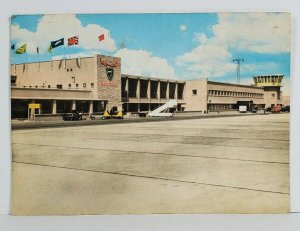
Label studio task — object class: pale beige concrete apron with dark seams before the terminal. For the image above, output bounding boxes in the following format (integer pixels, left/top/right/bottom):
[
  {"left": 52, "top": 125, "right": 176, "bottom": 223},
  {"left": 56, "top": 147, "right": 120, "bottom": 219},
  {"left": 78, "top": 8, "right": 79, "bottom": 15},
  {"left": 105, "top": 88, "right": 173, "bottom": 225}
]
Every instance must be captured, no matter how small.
[{"left": 12, "top": 114, "right": 289, "bottom": 215}]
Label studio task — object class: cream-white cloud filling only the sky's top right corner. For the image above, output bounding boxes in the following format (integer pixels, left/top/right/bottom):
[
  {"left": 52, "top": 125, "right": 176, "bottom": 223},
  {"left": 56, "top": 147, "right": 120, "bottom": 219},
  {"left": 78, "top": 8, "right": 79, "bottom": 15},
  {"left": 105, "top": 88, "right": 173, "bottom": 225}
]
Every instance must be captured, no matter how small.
[{"left": 212, "top": 13, "right": 290, "bottom": 54}]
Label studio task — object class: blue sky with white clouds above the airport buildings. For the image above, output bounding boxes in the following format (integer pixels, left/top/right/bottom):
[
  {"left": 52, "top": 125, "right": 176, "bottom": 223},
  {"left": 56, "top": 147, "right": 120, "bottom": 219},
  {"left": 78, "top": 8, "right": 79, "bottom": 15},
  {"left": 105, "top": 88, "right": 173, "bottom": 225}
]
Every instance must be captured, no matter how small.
[{"left": 10, "top": 13, "right": 290, "bottom": 95}]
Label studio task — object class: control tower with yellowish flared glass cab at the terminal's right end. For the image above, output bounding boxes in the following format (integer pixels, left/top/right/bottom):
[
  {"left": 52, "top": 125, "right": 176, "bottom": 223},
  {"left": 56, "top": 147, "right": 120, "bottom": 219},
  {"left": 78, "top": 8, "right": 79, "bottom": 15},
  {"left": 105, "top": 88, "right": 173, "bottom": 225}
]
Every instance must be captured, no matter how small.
[{"left": 253, "top": 74, "right": 284, "bottom": 107}]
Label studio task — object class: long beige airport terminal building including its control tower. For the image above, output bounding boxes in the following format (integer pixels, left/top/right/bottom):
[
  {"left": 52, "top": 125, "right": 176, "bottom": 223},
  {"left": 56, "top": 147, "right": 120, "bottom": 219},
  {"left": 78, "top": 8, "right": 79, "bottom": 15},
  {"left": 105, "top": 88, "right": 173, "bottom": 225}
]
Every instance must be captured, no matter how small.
[{"left": 11, "top": 55, "right": 283, "bottom": 118}]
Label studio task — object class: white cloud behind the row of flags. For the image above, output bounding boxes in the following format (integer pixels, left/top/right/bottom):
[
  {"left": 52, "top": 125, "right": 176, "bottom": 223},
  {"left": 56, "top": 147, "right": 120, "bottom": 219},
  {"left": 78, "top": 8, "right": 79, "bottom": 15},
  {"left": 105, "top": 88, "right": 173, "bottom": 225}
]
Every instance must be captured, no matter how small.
[{"left": 11, "top": 14, "right": 116, "bottom": 53}]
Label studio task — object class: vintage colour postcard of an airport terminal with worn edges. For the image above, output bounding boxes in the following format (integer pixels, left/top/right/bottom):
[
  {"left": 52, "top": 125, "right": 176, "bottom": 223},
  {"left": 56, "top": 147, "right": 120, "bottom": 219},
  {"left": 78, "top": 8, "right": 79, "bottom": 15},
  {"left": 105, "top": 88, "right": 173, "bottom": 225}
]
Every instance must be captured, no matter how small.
[{"left": 10, "top": 12, "right": 291, "bottom": 215}]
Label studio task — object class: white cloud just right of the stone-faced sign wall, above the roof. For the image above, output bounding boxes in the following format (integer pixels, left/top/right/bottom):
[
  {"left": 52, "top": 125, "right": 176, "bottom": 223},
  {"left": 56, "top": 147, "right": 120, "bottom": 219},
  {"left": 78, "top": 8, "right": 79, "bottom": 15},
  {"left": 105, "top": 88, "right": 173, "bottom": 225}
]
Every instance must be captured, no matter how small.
[{"left": 114, "top": 48, "right": 176, "bottom": 78}]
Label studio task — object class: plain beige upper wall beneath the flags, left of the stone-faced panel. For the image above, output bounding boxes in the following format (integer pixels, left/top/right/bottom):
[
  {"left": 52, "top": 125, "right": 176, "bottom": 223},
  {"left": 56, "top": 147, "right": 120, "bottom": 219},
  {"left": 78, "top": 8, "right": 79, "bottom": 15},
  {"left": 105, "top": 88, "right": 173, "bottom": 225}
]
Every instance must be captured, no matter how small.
[{"left": 11, "top": 57, "right": 98, "bottom": 99}]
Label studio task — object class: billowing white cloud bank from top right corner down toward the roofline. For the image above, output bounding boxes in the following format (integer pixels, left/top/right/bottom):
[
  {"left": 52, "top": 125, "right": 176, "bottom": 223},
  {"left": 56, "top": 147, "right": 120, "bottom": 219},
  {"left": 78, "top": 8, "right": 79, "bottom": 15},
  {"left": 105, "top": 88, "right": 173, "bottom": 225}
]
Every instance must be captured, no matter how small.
[{"left": 176, "top": 13, "right": 290, "bottom": 78}]
